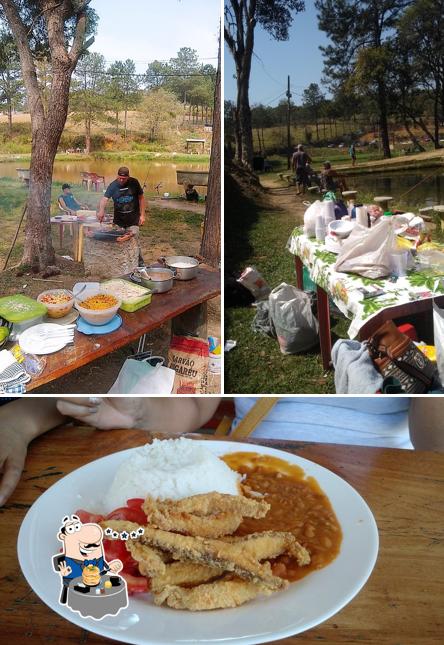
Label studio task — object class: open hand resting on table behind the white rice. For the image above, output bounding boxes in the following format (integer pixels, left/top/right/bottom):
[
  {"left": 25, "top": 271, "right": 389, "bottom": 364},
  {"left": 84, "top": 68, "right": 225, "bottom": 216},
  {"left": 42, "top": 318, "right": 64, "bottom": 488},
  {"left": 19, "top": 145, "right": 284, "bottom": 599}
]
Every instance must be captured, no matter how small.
[{"left": 57, "top": 397, "right": 143, "bottom": 430}]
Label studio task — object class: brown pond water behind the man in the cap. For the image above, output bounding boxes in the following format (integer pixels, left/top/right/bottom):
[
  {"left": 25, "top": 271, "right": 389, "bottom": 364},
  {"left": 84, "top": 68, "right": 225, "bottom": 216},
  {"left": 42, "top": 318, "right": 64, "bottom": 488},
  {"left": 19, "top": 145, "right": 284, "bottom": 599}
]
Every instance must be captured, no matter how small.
[{"left": 0, "top": 159, "right": 208, "bottom": 195}]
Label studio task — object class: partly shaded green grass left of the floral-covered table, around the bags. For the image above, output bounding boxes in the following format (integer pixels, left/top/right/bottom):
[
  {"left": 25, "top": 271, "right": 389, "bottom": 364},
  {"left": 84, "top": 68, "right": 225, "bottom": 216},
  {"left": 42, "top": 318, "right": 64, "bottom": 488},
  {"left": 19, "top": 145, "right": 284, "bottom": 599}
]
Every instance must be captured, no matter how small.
[{"left": 225, "top": 174, "right": 335, "bottom": 394}]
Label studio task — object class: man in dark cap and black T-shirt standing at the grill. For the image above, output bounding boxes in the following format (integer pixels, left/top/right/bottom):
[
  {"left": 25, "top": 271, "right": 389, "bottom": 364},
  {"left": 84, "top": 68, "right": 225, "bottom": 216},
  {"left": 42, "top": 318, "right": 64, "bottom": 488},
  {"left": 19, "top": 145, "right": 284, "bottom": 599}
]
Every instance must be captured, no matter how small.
[{"left": 97, "top": 166, "right": 145, "bottom": 264}]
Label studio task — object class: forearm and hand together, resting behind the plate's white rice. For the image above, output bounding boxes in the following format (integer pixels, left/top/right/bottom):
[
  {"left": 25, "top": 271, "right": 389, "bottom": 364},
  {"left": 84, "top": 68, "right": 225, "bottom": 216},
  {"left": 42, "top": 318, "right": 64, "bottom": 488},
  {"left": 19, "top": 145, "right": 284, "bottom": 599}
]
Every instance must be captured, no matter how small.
[{"left": 57, "top": 397, "right": 220, "bottom": 435}]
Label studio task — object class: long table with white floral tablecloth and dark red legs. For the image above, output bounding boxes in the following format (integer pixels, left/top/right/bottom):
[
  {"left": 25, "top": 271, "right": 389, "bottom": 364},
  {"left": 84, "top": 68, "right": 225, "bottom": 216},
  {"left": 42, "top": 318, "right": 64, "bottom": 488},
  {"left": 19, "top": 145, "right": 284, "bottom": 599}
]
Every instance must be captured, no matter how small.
[{"left": 287, "top": 226, "right": 444, "bottom": 369}]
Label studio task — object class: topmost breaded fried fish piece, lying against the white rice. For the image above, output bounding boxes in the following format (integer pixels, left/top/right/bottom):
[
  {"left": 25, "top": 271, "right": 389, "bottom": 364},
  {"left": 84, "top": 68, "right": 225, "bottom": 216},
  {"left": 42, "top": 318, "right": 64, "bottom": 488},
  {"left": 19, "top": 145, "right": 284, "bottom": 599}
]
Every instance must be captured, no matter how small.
[{"left": 143, "top": 493, "right": 270, "bottom": 538}]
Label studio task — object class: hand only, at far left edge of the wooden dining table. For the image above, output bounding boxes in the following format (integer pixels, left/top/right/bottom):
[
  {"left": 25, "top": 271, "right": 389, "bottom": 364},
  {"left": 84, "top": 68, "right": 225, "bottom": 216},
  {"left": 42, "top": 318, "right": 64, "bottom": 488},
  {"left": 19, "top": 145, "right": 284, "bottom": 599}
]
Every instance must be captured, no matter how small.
[{"left": 0, "top": 428, "right": 28, "bottom": 506}]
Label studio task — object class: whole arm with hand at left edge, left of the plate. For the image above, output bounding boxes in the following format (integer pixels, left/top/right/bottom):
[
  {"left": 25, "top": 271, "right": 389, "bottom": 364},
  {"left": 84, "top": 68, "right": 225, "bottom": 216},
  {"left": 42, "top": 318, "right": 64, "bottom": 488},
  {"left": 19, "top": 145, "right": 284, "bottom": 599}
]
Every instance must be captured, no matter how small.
[{"left": 0, "top": 398, "right": 66, "bottom": 506}]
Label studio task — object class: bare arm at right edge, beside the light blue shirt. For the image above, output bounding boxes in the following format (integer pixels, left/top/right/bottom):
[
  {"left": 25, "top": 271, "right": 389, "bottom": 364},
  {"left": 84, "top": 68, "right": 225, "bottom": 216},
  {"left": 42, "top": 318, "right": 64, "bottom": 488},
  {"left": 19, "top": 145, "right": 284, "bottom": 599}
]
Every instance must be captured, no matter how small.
[{"left": 409, "top": 396, "right": 444, "bottom": 452}]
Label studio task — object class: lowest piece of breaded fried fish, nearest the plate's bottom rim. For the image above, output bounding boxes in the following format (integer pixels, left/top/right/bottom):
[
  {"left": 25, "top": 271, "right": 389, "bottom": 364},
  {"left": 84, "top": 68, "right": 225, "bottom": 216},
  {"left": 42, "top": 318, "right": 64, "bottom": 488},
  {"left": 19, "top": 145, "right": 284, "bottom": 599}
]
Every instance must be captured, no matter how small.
[{"left": 154, "top": 580, "right": 272, "bottom": 611}]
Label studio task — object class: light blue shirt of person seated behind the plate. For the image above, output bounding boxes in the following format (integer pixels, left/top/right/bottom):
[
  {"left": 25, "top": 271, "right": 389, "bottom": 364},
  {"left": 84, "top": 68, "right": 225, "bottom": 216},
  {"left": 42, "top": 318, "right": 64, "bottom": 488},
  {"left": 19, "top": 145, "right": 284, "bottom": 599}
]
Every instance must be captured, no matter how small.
[{"left": 233, "top": 395, "right": 413, "bottom": 449}]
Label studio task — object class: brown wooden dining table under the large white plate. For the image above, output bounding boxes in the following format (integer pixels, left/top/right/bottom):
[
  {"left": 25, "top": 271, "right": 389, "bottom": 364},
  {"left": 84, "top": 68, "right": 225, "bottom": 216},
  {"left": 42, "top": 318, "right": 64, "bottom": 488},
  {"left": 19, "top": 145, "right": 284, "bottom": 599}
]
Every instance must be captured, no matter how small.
[{"left": 0, "top": 426, "right": 444, "bottom": 645}]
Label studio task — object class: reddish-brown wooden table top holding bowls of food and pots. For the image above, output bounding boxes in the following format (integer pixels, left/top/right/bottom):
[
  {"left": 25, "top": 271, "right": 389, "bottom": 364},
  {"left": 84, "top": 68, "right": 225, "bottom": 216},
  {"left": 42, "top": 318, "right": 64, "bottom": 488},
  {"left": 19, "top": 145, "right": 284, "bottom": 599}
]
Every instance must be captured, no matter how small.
[{"left": 27, "top": 264, "right": 220, "bottom": 391}]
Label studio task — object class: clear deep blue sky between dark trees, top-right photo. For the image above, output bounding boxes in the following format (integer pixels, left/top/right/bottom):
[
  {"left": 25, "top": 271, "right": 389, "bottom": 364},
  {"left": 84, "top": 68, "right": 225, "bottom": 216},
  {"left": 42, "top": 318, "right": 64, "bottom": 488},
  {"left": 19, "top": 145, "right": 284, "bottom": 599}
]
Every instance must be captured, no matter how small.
[{"left": 224, "top": 0, "right": 327, "bottom": 106}]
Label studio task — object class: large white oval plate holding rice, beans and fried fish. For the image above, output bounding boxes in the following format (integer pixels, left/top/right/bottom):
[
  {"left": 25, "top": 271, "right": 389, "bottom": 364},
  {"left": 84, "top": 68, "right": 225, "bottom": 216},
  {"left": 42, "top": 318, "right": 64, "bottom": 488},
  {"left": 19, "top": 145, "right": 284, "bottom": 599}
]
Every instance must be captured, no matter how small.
[{"left": 17, "top": 441, "right": 378, "bottom": 645}]
